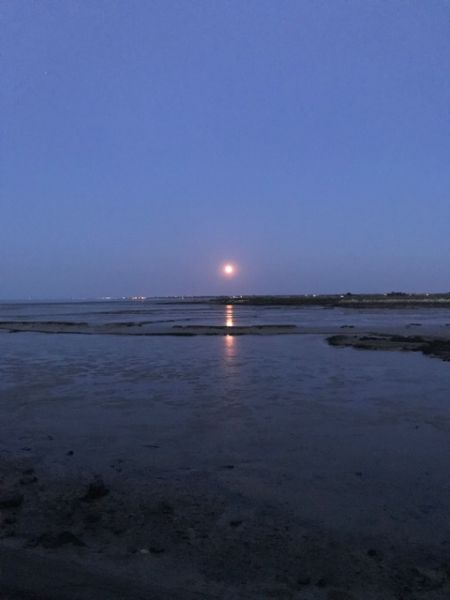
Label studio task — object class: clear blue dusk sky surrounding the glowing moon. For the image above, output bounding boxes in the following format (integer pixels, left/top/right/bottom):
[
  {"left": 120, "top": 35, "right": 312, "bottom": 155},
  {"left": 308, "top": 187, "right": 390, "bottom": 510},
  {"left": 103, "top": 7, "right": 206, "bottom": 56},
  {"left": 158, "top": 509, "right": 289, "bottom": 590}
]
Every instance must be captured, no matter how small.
[{"left": 0, "top": 0, "right": 450, "bottom": 299}]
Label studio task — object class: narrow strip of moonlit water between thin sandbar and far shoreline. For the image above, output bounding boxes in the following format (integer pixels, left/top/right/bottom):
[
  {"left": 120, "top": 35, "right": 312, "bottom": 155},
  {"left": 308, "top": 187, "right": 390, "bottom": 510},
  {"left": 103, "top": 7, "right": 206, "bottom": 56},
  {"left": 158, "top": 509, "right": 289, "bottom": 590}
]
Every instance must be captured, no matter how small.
[{"left": 0, "top": 300, "right": 450, "bottom": 327}]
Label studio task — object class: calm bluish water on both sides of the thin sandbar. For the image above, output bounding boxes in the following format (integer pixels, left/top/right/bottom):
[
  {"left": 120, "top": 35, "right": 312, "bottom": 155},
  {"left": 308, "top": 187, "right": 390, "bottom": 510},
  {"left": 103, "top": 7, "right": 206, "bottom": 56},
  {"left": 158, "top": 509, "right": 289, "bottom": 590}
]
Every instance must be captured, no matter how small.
[{"left": 0, "top": 302, "right": 450, "bottom": 540}]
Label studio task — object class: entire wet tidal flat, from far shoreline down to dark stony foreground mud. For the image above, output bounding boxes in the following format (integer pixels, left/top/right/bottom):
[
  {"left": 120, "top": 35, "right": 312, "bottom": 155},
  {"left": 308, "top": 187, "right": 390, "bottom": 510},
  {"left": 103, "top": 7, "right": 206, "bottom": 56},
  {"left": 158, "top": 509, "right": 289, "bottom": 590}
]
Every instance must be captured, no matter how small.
[{"left": 0, "top": 303, "right": 450, "bottom": 600}]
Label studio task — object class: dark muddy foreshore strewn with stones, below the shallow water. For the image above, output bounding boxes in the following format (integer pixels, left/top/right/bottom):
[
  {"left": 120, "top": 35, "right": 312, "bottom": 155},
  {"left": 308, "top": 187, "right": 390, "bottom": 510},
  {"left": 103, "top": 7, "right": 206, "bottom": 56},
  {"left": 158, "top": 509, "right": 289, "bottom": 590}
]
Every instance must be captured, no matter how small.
[{"left": 0, "top": 436, "right": 450, "bottom": 600}]
